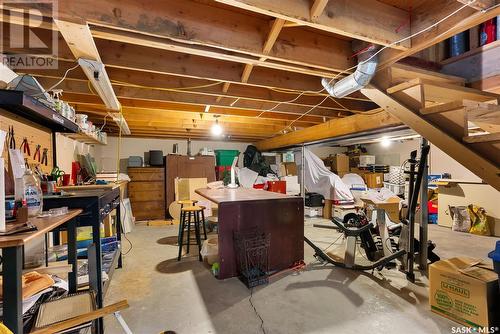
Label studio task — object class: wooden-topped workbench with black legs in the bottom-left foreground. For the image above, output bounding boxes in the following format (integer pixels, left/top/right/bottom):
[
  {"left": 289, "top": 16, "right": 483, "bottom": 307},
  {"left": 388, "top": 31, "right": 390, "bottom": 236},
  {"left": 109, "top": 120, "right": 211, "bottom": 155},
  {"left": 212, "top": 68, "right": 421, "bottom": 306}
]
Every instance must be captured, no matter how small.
[{"left": 0, "top": 209, "right": 82, "bottom": 333}]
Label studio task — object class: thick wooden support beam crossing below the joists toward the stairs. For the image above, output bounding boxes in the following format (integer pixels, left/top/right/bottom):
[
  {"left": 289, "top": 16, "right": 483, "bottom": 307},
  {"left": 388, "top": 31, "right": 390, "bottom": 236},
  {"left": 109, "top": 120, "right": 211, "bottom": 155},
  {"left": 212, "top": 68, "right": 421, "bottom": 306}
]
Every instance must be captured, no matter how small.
[{"left": 256, "top": 110, "right": 401, "bottom": 151}]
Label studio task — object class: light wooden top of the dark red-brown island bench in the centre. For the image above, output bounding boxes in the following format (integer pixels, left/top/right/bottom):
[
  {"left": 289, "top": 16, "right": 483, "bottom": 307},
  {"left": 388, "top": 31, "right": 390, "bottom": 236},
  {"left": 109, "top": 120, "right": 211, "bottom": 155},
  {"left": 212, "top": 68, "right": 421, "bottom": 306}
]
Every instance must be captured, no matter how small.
[{"left": 195, "top": 187, "right": 298, "bottom": 204}]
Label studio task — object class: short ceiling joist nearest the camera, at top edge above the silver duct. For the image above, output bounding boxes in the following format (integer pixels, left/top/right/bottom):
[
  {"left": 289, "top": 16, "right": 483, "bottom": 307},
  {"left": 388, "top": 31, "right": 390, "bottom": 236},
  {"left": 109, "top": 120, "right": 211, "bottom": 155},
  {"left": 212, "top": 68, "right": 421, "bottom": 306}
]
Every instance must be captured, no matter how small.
[{"left": 216, "top": 0, "right": 410, "bottom": 50}]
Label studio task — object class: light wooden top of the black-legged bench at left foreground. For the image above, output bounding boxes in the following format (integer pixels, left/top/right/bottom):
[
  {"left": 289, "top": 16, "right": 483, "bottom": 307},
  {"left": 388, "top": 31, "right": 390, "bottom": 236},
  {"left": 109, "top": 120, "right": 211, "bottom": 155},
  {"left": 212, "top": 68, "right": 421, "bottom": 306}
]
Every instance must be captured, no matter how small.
[{"left": 0, "top": 209, "right": 82, "bottom": 248}]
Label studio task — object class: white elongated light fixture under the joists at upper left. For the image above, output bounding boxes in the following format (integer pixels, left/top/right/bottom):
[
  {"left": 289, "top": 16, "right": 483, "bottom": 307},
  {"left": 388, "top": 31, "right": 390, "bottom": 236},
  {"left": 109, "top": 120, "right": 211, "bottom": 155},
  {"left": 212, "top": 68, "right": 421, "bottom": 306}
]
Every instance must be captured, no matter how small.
[{"left": 78, "top": 58, "right": 120, "bottom": 111}]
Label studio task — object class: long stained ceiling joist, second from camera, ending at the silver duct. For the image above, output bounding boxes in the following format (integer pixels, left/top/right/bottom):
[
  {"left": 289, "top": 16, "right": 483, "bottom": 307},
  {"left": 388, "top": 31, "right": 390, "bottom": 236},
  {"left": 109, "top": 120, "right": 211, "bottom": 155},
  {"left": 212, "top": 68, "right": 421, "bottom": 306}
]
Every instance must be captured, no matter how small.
[{"left": 34, "top": 0, "right": 352, "bottom": 74}]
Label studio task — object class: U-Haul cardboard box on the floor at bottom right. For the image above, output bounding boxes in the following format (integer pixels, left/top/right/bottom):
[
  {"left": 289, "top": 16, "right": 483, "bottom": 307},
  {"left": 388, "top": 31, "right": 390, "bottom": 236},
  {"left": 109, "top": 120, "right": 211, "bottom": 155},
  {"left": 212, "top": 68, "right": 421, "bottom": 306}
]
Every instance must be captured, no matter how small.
[{"left": 429, "top": 257, "right": 500, "bottom": 333}]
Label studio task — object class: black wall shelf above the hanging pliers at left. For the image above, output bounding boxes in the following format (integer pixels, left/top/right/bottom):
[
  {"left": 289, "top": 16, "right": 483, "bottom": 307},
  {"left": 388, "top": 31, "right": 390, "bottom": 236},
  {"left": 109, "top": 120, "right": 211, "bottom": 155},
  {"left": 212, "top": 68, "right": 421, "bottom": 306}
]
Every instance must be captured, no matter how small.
[{"left": 0, "top": 89, "right": 78, "bottom": 133}]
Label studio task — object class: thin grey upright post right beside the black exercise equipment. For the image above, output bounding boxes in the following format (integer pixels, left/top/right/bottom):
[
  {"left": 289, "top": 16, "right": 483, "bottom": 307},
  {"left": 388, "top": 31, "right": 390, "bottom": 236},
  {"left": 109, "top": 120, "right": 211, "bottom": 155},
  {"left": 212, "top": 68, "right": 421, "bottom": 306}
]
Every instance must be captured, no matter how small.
[{"left": 419, "top": 137, "right": 430, "bottom": 271}]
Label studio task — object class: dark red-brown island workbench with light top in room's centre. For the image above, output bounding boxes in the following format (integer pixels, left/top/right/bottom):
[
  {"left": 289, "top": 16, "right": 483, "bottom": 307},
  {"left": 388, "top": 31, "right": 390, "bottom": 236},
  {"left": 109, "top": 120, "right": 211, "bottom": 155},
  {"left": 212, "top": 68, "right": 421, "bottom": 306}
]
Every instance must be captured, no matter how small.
[{"left": 196, "top": 188, "right": 304, "bottom": 279}]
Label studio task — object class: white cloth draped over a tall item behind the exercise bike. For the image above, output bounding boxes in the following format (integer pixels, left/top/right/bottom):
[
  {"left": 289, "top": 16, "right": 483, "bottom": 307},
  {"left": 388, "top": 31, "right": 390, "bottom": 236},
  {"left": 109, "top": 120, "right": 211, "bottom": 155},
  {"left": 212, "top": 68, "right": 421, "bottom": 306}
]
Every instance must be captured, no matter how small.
[{"left": 304, "top": 148, "right": 354, "bottom": 201}]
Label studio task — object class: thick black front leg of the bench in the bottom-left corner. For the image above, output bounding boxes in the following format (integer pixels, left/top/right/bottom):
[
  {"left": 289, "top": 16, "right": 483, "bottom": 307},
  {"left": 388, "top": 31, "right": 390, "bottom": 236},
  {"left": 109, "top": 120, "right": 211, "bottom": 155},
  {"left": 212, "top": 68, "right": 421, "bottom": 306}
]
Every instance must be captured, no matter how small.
[{"left": 2, "top": 246, "right": 23, "bottom": 334}]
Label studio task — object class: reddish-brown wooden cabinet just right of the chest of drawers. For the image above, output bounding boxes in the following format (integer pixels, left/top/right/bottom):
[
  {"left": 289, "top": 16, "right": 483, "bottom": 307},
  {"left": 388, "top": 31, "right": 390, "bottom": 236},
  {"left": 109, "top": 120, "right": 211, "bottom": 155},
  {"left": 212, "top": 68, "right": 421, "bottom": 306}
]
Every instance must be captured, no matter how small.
[{"left": 165, "top": 155, "right": 215, "bottom": 208}]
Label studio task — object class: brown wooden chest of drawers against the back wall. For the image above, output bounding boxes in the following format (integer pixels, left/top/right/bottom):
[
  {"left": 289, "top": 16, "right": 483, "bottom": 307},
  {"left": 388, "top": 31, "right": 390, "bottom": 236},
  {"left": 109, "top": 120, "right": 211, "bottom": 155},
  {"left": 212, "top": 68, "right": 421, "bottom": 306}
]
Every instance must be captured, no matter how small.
[{"left": 128, "top": 167, "right": 166, "bottom": 220}]
